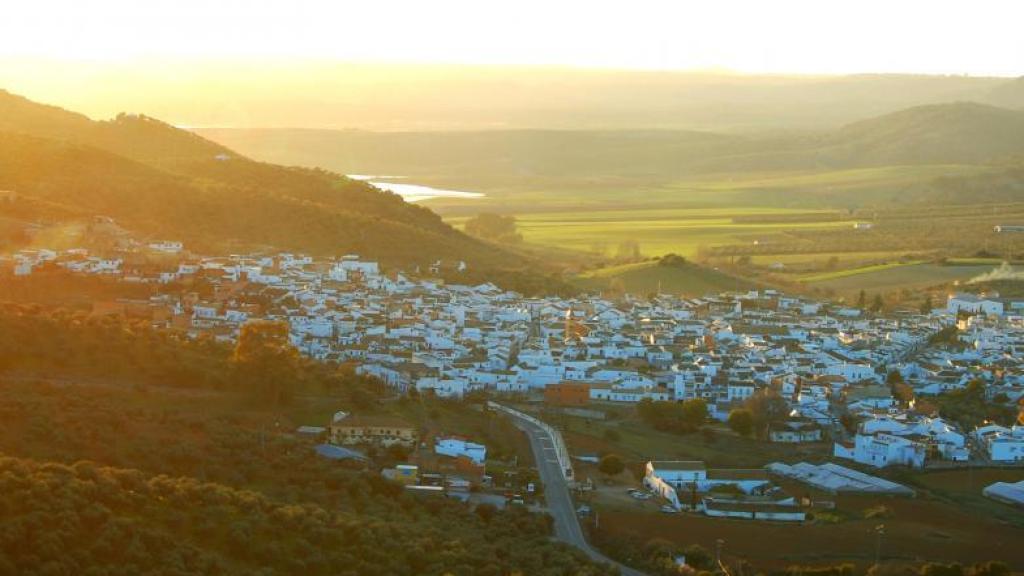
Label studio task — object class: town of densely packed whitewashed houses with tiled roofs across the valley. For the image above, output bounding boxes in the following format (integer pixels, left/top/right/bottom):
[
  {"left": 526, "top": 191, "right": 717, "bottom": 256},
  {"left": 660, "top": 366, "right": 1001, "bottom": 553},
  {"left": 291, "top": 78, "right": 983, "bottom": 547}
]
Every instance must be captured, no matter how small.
[{"left": 4, "top": 241, "right": 1024, "bottom": 466}]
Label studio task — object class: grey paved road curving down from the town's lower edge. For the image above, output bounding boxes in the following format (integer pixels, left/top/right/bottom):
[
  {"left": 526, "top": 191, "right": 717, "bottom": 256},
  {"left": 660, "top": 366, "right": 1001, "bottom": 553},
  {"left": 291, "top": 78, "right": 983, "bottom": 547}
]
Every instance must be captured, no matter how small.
[{"left": 513, "top": 409, "right": 645, "bottom": 576}]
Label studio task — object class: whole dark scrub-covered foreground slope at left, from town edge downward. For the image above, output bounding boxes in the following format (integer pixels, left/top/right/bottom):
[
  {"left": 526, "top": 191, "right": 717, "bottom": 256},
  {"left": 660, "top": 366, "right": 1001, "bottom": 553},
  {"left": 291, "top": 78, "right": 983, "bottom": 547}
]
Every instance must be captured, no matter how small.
[{"left": 0, "top": 307, "right": 604, "bottom": 575}]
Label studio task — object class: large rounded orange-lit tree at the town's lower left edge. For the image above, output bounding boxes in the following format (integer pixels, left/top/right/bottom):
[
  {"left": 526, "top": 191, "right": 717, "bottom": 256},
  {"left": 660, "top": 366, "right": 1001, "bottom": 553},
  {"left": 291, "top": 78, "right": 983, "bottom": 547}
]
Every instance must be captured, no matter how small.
[{"left": 231, "top": 321, "right": 301, "bottom": 405}]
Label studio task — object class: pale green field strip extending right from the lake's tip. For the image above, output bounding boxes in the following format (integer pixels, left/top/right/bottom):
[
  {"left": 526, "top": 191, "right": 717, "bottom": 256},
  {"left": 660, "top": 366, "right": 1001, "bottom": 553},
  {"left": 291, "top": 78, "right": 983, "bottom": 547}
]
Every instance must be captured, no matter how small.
[{"left": 434, "top": 164, "right": 992, "bottom": 216}]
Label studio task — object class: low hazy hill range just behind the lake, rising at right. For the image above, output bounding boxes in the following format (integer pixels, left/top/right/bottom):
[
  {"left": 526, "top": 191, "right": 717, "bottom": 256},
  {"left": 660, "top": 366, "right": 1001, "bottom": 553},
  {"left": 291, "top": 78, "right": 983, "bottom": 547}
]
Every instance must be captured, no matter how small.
[{"left": 198, "top": 101, "right": 1024, "bottom": 180}]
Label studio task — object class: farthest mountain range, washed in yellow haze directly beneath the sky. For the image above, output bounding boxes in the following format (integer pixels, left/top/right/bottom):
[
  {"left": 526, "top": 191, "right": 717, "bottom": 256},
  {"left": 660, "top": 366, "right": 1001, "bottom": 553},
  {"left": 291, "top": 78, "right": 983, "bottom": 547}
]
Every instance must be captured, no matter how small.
[{"left": 6, "top": 63, "right": 1024, "bottom": 133}]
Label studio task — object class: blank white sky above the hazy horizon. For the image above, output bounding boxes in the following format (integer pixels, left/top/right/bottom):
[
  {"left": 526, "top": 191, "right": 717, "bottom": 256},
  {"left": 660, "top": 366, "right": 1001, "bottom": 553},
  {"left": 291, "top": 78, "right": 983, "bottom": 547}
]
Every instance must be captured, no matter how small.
[{"left": 0, "top": 0, "right": 1024, "bottom": 76}]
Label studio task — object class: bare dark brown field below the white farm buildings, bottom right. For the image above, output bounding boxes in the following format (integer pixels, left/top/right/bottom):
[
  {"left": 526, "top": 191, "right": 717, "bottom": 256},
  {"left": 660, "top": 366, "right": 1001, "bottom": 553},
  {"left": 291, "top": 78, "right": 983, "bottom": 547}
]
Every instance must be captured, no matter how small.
[{"left": 594, "top": 489, "right": 1024, "bottom": 570}]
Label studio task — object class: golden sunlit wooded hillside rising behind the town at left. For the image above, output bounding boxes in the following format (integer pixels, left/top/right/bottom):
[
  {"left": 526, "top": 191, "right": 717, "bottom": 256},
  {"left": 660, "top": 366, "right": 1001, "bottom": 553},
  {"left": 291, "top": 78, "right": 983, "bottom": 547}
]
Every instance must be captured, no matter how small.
[{"left": 0, "top": 88, "right": 544, "bottom": 280}]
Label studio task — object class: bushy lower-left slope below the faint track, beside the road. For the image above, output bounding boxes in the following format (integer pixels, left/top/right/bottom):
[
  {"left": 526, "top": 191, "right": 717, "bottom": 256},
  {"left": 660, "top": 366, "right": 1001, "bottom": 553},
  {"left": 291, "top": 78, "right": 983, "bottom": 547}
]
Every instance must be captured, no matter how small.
[{"left": 0, "top": 383, "right": 600, "bottom": 575}]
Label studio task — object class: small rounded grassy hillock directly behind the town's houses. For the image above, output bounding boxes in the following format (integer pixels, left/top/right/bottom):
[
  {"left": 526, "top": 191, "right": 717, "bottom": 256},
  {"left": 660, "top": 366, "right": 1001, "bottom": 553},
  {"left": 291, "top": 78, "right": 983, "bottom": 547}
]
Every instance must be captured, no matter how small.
[{"left": 572, "top": 261, "right": 754, "bottom": 296}]
